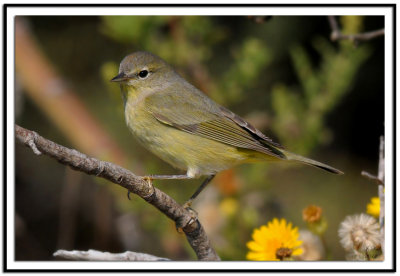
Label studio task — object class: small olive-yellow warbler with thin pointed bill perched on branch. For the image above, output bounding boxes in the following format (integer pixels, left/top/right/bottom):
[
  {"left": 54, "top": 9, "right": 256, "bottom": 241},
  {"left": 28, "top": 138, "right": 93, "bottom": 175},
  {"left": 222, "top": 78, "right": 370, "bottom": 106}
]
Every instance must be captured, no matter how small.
[{"left": 111, "top": 51, "right": 342, "bottom": 205}]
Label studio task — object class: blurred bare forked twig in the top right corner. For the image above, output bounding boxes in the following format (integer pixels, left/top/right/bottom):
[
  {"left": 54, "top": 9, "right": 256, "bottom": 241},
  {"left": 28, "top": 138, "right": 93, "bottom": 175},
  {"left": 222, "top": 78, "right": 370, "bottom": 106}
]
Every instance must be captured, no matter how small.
[{"left": 328, "top": 16, "right": 385, "bottom": 44}]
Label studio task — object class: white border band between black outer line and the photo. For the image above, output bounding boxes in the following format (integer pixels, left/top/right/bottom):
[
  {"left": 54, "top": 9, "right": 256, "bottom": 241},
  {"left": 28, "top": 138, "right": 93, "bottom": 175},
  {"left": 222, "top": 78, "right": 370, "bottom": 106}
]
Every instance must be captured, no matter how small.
[{"left": 1, "top": 6, "right": 394, "bottom": 269}]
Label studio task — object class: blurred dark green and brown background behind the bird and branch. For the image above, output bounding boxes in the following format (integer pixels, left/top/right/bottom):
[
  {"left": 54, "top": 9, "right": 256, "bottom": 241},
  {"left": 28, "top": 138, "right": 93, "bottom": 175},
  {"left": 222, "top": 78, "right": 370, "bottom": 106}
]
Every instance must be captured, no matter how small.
[{"left": 15, "top": 16, "right": 384, "bottom": 260}]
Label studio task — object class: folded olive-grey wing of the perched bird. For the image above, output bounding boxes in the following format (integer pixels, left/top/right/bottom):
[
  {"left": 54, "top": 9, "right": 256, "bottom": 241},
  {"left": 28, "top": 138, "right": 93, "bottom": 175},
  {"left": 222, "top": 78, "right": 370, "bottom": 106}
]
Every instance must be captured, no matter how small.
[{"left": 146, "top": 88, "right": 286, "bottom": 159}]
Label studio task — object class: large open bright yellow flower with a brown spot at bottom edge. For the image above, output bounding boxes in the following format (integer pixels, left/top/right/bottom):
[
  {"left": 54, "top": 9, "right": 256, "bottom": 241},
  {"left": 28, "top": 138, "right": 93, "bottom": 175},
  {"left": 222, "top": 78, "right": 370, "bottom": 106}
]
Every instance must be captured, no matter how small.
[{"left": 246, "top": 218, "right": 303, "bottom": 261}]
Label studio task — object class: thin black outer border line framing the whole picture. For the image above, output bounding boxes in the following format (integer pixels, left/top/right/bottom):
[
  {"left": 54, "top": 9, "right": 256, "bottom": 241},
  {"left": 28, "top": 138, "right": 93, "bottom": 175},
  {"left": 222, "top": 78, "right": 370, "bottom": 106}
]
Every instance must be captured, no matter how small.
[{"left": 2, "top": 3, "right": 397, "bottom": 273}]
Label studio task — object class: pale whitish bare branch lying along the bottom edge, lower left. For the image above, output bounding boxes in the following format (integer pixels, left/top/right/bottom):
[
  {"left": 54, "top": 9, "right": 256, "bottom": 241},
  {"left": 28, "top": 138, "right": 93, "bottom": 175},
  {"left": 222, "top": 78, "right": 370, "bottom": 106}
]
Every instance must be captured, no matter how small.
[{"left": 53, "top": 249, "right": 170, "bottom": 261}]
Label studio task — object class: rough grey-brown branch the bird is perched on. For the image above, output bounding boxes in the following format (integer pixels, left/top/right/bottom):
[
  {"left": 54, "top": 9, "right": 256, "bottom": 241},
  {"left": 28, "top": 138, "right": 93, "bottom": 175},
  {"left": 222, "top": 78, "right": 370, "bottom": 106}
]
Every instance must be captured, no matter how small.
[{"left": 15, "top": 125, "right": 220, "bottom": 261}]
